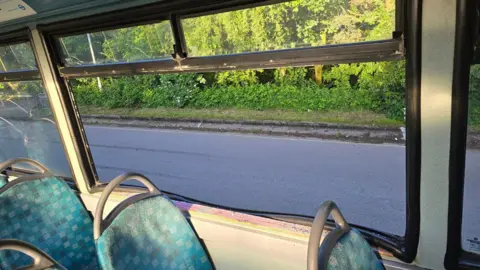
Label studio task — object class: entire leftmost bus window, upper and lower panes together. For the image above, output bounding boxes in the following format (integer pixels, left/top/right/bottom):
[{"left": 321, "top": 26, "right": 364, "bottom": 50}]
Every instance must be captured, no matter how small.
[{"left": 0, "top": 33, "right": 71, "bottom": 177}]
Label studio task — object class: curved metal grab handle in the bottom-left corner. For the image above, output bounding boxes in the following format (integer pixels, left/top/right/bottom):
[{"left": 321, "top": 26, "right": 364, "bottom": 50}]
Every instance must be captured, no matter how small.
[{"left": 0, "top": 239, "right": 63, "bottom": 270}]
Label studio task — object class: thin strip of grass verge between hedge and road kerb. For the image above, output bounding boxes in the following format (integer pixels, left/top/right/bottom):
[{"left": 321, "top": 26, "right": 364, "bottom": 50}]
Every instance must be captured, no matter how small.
[{"left": 79, "top": 106, "right": 403, "bottom": 127}]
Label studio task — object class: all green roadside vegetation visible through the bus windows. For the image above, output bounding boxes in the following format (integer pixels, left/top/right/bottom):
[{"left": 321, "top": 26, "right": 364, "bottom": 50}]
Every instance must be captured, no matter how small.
[{"left": 0, "top": 0, "right": 480, "bottom": 126}]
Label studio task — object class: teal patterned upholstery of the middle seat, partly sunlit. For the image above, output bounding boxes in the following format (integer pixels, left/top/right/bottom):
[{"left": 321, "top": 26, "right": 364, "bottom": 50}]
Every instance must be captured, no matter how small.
[{"left": 96, "top": 195, "right": 212, "bottom": 270}]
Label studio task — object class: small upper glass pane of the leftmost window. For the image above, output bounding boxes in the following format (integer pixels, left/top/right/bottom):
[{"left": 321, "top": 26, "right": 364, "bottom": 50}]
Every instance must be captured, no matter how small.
[{"left": 0, "top": 43, "right": 37, "bottom": 72}]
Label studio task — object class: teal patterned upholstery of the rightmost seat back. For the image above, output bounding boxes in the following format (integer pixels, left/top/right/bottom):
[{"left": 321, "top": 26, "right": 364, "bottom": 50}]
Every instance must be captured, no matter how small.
[{"left": 328, "top": 229, "right": 385, "bottom": 270}]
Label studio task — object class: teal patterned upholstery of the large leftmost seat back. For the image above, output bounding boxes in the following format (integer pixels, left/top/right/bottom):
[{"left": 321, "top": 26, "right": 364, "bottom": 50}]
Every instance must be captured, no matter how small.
[{"left": 0, "top": 177, "right": 98, "bottom": 269}]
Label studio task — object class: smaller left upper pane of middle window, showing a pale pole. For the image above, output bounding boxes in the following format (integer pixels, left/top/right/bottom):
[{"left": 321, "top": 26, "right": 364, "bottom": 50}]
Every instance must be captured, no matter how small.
[{"left": 60, "top": 21, "right": 174, "bottom": 66}]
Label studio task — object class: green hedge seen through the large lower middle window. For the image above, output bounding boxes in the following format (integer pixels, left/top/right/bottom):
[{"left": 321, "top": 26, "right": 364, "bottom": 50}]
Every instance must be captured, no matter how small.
[{"left": 73, "top": 69, "right": 404, "bottom": 119}]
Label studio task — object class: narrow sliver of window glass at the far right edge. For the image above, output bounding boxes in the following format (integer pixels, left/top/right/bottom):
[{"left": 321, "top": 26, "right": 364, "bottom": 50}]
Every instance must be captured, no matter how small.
[{"left": 462, "top": 65, "right": 480, "bottom": 254}]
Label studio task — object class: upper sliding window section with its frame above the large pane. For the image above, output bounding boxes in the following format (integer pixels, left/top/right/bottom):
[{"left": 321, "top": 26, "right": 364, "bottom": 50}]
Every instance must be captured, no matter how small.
[{"left": 53, "top": 0, "right": 403, "bottom": 78}]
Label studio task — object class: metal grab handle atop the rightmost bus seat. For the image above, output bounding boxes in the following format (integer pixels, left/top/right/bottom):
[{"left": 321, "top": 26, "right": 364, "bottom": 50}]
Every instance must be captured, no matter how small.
[{"left": 307, "top": 201, "right": 350, "bottom": 270}]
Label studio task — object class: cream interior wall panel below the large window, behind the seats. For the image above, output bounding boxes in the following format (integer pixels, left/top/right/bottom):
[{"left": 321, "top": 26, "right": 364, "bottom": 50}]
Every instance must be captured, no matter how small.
[{"left": 81, "top": 193, "right": 419, "bottom": 269}]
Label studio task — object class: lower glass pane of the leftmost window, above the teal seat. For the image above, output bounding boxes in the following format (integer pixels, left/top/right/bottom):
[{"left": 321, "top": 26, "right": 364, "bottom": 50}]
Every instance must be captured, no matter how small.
[{"left": 0, "top": 81, "right": 71, "bottom": 177}]
